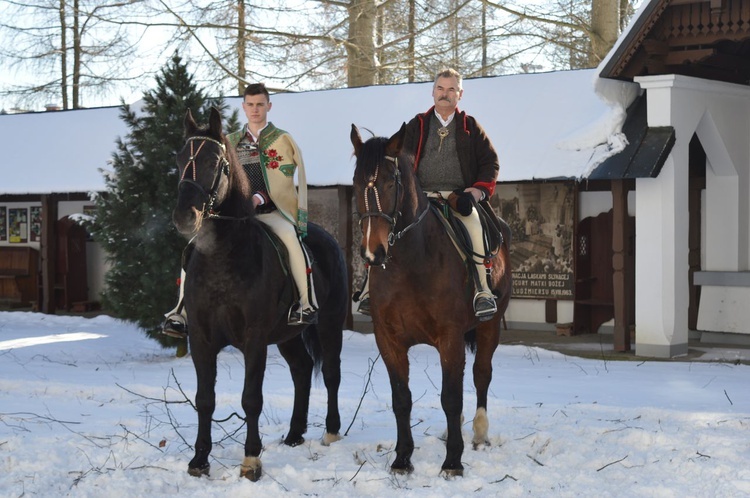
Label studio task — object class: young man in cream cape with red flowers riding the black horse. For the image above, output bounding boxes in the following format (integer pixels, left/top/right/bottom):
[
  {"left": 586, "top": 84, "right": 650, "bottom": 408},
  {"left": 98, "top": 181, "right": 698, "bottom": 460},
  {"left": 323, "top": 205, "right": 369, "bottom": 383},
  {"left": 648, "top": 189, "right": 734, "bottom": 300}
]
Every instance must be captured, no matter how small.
[{"left": 162, "top": 83, "right": 318, "bottom": 337}]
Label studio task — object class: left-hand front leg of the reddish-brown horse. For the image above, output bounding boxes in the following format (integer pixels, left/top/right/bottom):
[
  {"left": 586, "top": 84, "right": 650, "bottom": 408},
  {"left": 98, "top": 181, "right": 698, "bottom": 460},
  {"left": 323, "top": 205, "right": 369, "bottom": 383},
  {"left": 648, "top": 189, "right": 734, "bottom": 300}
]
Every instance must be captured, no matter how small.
[{"left": 375, "top": 330, "right": 414, "bottom": 474}]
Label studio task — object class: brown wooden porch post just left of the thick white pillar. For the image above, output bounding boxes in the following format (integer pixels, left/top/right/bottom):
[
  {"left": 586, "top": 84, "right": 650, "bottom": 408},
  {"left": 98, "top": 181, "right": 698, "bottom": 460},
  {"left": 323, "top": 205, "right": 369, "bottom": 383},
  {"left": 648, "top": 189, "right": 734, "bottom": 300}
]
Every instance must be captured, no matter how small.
[{"left": 612, "top": 180, "right": 633, "bottom": 351}]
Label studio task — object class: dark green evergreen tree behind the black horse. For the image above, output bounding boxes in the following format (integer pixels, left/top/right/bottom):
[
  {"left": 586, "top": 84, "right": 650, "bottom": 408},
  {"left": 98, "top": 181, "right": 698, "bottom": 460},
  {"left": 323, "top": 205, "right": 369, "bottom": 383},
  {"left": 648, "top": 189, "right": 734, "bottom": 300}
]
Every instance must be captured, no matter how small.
[{"left": 87, "top": 54, "right": 239, "bottom": 345}]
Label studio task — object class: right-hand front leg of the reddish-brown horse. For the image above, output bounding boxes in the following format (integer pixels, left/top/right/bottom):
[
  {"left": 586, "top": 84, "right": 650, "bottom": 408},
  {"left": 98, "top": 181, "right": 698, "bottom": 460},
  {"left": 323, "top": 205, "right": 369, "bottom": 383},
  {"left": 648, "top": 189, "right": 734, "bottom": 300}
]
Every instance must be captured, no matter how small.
[{"left": 439, "top": 332, "right": 466, "bottom": 477}]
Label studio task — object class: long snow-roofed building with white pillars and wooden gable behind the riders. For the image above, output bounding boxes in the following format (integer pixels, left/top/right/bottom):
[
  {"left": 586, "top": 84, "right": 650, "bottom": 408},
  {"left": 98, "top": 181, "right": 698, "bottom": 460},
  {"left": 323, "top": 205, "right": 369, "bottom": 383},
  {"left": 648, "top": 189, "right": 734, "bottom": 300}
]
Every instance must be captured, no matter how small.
[{"left": 0, "top": 0, "right": 750, "bottom": 357}]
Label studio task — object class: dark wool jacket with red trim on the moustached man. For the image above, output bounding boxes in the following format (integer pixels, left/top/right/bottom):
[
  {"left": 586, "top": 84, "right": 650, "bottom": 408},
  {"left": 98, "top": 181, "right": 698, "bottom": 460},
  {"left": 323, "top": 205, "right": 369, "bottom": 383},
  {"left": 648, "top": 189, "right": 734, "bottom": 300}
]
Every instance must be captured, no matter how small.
[{"left": 404, "top": 106, "right": 500, "bottom": 198}]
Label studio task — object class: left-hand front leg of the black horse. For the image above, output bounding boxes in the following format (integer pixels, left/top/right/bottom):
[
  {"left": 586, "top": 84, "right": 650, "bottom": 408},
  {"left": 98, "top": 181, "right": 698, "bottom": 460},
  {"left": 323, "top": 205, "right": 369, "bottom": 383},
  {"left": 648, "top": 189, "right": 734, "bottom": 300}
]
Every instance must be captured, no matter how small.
[{"left": 188, "top": 342, "right": 216, "bottom": 477}]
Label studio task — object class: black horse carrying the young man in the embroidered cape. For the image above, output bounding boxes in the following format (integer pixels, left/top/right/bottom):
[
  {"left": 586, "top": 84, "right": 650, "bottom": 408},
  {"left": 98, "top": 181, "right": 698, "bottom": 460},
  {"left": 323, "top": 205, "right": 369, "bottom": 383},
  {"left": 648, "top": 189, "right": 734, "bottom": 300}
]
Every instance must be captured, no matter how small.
[{"left": 172, "top": 109, "right": 349, "bottom": 481}]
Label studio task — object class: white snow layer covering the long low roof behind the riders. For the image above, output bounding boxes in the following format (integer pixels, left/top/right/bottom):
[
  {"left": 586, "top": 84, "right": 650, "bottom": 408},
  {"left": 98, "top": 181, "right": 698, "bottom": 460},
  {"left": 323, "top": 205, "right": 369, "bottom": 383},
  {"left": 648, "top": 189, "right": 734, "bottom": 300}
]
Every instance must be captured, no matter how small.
[{"left": 0, "top": 69, "right": 637, "bottom": 194}]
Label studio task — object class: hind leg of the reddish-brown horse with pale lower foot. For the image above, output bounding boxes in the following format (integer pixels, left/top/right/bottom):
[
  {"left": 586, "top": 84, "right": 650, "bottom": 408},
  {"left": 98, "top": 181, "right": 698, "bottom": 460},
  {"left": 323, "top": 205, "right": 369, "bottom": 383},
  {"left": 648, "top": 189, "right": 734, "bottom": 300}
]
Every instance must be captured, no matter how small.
[{"left": 471, "top": 316, "right": 500, "bottom": 449}]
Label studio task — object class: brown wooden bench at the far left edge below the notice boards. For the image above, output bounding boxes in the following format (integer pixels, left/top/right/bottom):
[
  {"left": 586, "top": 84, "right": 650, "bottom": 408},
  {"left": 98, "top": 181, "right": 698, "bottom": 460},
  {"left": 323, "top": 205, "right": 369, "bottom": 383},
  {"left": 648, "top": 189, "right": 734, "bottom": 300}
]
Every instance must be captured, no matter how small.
[{"left": 0, "top": 246, "right": 39, "bottom": 306}]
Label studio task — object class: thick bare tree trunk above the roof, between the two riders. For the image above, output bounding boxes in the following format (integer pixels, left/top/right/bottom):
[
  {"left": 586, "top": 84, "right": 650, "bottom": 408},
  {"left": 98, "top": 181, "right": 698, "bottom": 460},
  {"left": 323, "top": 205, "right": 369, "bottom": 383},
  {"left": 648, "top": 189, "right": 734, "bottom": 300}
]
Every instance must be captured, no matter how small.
[{"left": 346, "top": 0, "right": 377, "bottom": 87}]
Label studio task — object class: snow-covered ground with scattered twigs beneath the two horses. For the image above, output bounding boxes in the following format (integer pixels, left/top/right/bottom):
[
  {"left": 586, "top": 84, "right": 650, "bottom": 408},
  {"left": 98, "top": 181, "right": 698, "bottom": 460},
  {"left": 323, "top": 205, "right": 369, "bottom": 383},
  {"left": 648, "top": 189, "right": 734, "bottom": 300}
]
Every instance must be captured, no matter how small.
[{"left": 0, "top": 312, "right": 750, "bottom": 498}]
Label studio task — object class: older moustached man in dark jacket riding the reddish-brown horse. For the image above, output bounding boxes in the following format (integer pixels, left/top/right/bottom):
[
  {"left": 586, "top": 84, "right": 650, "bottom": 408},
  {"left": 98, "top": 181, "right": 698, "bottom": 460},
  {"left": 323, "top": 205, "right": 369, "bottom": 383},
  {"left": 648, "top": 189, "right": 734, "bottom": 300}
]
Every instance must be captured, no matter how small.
[{"left": 358, "top": 69, "right": 500, "bottom": 320}]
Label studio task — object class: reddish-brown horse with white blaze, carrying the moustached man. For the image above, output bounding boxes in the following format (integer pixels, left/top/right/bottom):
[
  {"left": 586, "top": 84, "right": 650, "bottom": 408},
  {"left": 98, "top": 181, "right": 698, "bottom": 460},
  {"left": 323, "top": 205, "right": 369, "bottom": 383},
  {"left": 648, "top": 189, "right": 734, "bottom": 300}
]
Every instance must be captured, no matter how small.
[{"left": 351, "top": 125, "right": 511, "bottom": 476}]
